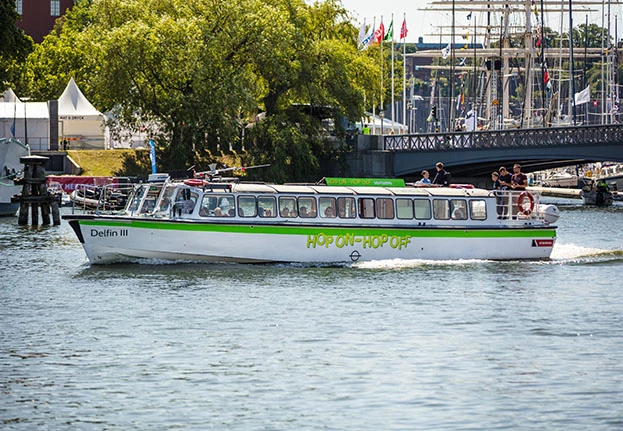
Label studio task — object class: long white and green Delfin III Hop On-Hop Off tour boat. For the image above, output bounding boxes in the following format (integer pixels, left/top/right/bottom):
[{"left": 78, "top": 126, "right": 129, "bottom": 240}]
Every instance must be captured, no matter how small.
[{"left": 63, "top": 174, "right": 559, "bottom": 264}]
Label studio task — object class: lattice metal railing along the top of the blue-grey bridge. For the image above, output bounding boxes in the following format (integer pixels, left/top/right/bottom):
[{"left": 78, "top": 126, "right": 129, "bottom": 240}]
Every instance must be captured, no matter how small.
[{"left": 384, "top": 124, "right": 623, "bottom": 151}]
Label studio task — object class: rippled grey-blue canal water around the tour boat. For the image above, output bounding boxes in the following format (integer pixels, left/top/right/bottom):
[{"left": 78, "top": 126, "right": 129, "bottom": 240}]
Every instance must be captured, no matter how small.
[{"left": 0, "top": 201, "right": 623, "bottom": 431}]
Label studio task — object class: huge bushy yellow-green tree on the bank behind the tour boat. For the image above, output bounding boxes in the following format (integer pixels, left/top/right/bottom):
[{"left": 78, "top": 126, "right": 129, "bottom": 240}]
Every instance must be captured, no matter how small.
[{"left": 20, "top": 0, "right": 380, "bottom": 179}]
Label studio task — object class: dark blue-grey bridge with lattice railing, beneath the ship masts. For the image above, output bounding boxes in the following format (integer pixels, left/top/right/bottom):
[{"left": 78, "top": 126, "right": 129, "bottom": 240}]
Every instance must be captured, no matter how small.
[{"left": 378, "top": 124, "right": 623, "bottom": 179}]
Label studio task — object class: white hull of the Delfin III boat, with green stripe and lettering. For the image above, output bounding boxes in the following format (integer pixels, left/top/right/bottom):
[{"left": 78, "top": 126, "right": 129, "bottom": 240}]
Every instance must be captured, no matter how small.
[{"left": 70, "top": 215, "right": 556, "bottom": 264}]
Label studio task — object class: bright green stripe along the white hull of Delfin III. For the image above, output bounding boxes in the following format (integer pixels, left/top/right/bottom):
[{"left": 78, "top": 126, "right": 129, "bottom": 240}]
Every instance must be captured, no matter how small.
[{"left": 80, "top": 220, "right": 556, "bottom": 238}]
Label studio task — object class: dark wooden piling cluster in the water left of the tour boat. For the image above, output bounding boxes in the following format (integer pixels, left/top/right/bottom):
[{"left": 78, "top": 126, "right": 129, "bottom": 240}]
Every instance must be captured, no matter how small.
[{"left": 11, "top": 156, "right": 61, "bottom": 226}]
